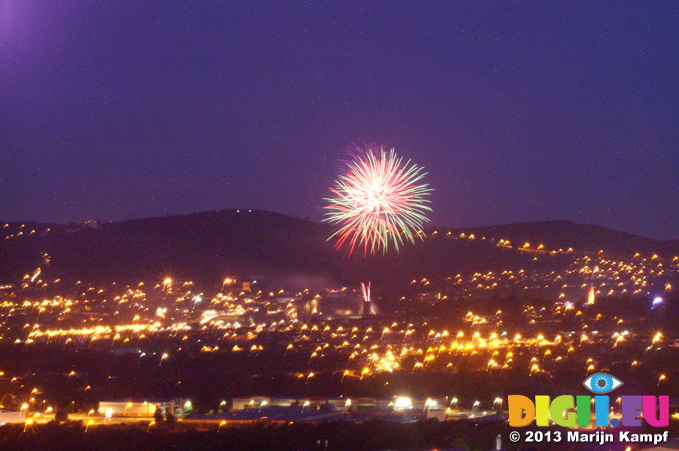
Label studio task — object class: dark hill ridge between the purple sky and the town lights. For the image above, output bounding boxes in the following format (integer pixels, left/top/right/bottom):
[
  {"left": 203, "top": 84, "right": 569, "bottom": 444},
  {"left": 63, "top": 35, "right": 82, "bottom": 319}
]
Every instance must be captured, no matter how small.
[{"left": 0, "top": 209, "right": 679, "bottom": 287}]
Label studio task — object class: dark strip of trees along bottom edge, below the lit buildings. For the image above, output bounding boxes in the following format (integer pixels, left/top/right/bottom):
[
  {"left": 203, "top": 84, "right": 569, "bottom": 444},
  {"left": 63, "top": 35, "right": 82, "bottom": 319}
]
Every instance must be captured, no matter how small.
[{"left": 0, "top": 420, "right": 678, "bottom": 451}]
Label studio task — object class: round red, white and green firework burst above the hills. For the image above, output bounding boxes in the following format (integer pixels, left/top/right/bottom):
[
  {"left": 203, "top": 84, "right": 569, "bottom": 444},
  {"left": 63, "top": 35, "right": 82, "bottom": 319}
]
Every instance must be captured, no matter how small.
[{"left": 323, "top": 145, "right": 432, "bottom": 255}]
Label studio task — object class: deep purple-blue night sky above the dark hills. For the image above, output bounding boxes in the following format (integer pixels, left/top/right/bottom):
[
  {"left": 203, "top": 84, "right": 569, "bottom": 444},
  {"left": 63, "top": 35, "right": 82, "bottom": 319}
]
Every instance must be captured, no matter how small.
[{"left": 0, "top": 0, "right": 679, "bottom": 239}]
